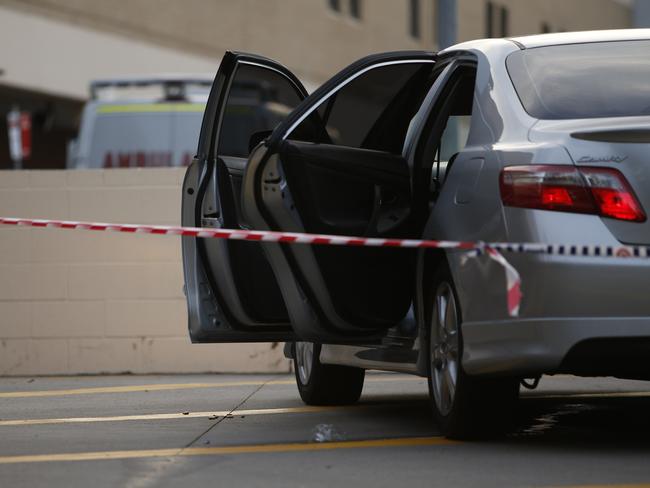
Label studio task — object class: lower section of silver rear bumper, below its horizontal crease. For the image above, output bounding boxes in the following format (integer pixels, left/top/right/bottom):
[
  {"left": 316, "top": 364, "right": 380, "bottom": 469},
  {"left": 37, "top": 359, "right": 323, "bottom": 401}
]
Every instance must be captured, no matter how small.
[{"left": 462, "top": 316, "right": 650, "bottom": 377}]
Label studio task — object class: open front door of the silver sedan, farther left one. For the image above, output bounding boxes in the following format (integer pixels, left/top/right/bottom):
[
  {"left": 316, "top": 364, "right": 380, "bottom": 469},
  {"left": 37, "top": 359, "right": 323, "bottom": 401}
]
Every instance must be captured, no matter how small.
[{"left": 182, "top": 52, "right": 307, "bottom": 342}]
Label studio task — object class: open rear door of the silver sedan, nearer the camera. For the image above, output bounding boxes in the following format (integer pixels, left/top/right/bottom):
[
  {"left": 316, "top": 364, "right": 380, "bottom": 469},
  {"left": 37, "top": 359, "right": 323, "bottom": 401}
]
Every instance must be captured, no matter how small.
[{"left": 242, "top": 52, "right": 435, "bottom": 343}]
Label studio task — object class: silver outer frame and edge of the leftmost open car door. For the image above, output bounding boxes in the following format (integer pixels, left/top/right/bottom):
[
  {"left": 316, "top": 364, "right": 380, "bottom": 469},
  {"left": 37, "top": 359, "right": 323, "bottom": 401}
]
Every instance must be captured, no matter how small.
[{"left": 181, "top": 48, "right": 307, "bottom": 342}]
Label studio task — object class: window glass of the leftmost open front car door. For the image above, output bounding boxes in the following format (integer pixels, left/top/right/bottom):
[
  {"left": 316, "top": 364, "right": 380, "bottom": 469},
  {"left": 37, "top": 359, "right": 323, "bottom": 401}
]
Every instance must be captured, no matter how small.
[{"left": 217, "top": 64, "right": 302, "bottom": 158}]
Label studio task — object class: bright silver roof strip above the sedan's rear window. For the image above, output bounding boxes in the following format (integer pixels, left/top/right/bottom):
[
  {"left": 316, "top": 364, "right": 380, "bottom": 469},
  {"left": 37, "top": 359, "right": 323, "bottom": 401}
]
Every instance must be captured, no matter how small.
[{"left": 510, "top": 29, "right": 650, "bottom": 49}]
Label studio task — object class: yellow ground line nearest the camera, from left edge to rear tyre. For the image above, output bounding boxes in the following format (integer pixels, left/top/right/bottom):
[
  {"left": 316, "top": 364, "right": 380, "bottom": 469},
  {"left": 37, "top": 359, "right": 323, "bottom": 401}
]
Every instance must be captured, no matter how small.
[{"left": 0, "top": 437, "right": 450, "bottom": 464}]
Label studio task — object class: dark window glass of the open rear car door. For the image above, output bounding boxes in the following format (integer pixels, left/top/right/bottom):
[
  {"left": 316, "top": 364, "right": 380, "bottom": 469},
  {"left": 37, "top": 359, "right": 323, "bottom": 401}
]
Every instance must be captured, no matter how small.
[{"left": 288, "top": 63, "right": 433, "bottom": 154}]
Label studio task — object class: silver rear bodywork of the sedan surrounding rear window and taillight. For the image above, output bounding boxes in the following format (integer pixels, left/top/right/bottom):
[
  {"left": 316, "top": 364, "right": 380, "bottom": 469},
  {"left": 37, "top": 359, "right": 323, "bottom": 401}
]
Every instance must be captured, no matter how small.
[{"left": 424, "top": 35, "right": 650, "bottom": 376}]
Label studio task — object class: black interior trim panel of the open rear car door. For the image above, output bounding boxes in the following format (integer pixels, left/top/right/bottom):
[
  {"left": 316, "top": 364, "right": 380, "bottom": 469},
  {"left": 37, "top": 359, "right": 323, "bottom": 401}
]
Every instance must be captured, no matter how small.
[{"left": 276, "top": 142, "right": 413, "bottom": 329}]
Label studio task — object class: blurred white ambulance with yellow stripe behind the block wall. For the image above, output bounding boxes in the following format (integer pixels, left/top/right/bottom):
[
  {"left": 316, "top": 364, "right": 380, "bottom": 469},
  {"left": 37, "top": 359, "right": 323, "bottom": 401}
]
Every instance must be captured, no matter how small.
[{"left": 67, "top": 76, "right": 212, "bottom": 168}]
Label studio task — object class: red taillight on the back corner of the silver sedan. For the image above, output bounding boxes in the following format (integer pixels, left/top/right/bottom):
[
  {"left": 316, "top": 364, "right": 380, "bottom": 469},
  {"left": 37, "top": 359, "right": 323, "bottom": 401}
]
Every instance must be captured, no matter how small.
[{"left": 499, "top": 165, "right": 646, "bottom": 222}]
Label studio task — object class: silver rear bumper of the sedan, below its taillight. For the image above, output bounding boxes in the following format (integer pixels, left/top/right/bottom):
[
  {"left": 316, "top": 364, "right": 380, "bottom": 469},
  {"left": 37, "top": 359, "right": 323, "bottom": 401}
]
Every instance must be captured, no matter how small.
[{"left": 447, "top": 207, "right": 650, "bottom": 376}]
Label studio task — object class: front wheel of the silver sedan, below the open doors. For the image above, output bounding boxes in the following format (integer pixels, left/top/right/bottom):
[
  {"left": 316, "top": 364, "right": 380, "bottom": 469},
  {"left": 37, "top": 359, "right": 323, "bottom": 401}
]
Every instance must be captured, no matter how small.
[{"left": 293, "top": 342, "right": 366, "bottom": 405}]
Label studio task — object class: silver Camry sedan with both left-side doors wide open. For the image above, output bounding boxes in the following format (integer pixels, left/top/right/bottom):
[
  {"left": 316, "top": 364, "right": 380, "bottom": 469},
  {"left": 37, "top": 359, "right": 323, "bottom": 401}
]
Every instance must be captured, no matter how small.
[{"left": 183, "top": 30, "right": 650, "bottom": 437}]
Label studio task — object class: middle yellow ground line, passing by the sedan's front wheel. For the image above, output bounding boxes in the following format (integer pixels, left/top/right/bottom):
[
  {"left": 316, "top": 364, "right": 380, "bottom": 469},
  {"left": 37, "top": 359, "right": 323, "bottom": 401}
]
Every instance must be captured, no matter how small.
[{"left": 0, "top": 375, "right": 422, "bottom": 398}]
